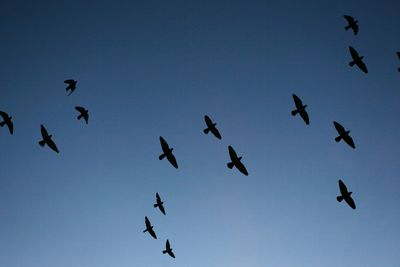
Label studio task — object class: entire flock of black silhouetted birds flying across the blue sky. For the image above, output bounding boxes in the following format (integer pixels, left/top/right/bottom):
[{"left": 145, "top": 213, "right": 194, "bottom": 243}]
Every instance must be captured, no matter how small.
[{"left": 0, "top": 15, "right": 400, "bottom": 258}]
